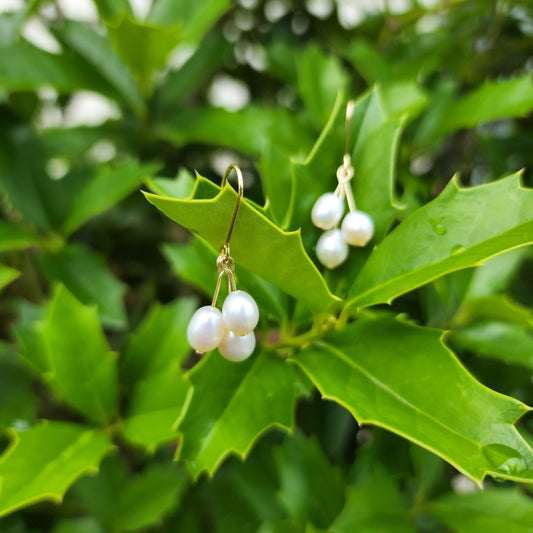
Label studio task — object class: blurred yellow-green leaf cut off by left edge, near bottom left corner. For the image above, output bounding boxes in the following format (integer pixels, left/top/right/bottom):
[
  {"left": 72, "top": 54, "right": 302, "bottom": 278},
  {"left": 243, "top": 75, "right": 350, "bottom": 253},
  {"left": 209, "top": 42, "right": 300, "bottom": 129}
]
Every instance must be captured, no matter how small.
[{"left": 0, "top": 422, "right": 112, "bottom": 516}]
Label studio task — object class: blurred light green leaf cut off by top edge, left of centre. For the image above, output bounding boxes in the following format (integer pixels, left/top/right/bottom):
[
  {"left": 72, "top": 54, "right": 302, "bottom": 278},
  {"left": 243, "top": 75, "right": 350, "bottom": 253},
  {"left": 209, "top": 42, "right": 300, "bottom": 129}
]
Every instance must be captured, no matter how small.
[{"left": 148, "top": 0, "right": 230, "bottom": 43}]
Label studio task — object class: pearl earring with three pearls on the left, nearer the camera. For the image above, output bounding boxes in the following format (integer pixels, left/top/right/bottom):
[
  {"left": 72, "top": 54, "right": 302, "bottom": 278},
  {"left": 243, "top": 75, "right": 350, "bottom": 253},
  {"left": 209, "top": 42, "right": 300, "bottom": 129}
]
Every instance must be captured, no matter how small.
[{"left": 187, "top": 165, "right": 259, "bottom": 361}]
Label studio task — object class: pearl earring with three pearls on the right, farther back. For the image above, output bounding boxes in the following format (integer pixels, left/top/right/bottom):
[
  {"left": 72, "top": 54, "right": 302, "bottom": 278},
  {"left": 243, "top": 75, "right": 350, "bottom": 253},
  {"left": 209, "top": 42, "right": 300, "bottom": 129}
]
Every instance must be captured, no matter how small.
[{"left": 311, "top": 100, "right": 374, "bottom": 268}]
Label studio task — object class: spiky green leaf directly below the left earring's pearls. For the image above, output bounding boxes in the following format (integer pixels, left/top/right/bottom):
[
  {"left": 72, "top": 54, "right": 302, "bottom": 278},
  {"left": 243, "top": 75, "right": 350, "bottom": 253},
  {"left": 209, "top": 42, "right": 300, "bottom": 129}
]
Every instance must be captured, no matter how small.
[{"left": 177, "top": 350, "right": 295, "bottom": 478}]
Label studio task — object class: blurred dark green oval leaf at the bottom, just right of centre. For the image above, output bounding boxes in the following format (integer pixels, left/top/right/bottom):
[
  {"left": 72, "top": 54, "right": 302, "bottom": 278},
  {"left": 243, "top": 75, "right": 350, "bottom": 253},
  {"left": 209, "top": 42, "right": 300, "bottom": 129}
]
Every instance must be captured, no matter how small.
[{"left": 274, "top": 433, "right": 344, "bottom": 528}]
